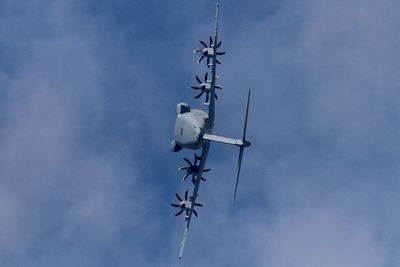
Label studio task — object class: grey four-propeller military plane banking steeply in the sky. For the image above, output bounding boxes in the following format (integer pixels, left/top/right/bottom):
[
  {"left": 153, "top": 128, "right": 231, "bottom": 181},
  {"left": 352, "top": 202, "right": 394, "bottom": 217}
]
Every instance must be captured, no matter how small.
[{"left": 170, "top": 3, "right": 251, "bottom": 259}]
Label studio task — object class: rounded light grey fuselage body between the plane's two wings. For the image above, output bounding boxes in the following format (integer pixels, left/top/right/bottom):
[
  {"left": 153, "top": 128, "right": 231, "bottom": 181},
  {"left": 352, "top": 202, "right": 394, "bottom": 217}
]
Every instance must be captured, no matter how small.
[{"left": 174, "top": 109, "right": 208, "bottom": 149}]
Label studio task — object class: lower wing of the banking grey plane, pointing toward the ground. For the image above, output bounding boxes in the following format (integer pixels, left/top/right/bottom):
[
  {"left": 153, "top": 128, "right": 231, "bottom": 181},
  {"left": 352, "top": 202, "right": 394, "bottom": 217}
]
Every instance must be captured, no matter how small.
[{"left": 179, "top": 141, "right": 210, "bottom": 259}]
